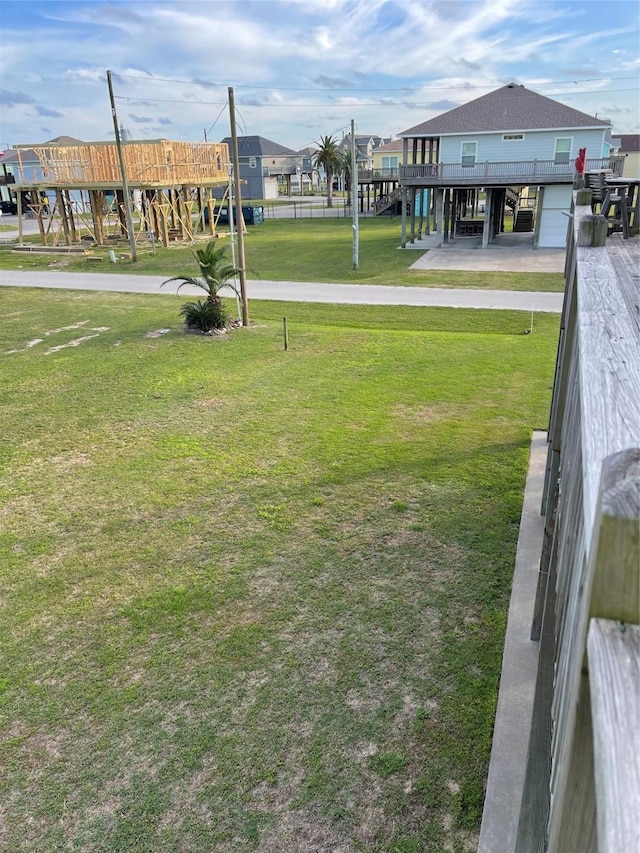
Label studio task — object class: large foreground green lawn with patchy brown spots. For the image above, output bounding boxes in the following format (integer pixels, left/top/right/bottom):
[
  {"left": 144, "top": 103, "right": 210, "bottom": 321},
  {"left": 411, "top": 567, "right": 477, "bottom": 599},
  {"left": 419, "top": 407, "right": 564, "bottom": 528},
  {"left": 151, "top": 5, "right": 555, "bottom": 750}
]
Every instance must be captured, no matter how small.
[{"left": 0, "top": 288, "right": 559, "bottom": 853}]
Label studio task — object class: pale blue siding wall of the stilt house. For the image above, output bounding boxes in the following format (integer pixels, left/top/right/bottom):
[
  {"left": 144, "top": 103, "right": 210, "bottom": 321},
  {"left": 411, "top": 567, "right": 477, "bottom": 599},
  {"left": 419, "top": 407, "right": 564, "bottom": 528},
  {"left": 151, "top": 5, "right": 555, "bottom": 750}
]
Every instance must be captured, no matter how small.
[{"left": 440, "top": 128, "right": 604, "bottom": 163}]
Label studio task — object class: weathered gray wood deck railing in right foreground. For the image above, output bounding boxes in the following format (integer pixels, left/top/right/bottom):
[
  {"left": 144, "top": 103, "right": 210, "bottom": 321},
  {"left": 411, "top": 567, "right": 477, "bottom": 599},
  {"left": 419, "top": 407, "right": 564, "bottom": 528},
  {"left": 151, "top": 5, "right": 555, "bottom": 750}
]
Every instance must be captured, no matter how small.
[{"left": 516, "top": 190, "right": 640, "bottom": 853}]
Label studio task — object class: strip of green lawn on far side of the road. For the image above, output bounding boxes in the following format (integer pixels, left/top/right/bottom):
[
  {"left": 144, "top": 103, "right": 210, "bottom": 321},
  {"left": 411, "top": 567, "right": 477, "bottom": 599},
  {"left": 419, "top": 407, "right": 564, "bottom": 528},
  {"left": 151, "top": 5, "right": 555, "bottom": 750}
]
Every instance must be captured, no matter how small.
[{"left": 0, "top": 218, "right": 564, "bottom": 292}]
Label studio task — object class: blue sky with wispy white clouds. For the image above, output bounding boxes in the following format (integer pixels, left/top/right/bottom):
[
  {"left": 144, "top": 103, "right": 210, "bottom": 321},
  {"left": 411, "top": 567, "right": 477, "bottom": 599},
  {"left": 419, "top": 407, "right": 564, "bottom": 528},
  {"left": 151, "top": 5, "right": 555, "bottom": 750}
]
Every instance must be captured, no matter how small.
[{"left": 0, "top": 0, "right": 640, "bottom": 150}]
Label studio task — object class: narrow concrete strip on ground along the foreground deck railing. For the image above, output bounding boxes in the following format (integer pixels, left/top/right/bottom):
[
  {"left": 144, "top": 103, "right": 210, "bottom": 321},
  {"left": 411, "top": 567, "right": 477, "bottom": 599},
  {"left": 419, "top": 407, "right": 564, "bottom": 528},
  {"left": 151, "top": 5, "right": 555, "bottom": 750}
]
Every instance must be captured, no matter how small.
[{"left": 478, "top": 432, "right": 547, "bottom": 853}]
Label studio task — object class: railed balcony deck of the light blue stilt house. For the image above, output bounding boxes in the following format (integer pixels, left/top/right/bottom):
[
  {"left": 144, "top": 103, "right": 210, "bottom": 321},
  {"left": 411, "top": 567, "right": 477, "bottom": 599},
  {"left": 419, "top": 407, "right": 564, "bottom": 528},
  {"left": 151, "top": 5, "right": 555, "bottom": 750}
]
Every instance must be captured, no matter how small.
[{"left": 400, "top": 157, "right": 624, "bottom": 187}]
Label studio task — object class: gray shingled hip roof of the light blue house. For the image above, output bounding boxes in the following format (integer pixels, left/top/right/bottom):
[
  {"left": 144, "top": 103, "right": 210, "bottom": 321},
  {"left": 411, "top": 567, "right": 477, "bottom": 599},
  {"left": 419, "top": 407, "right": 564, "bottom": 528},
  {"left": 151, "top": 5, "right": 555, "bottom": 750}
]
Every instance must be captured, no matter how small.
[{"left": 400, "top": 83, "right": 610, "bottom": 136}]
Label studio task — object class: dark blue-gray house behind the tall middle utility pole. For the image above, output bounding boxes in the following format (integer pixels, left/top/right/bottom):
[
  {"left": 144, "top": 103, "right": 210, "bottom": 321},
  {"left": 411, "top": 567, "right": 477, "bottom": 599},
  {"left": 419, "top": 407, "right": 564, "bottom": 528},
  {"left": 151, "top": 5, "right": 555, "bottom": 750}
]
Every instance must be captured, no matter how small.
[{"left": 222, "top": 136, "right": 301, "bottom": 199}]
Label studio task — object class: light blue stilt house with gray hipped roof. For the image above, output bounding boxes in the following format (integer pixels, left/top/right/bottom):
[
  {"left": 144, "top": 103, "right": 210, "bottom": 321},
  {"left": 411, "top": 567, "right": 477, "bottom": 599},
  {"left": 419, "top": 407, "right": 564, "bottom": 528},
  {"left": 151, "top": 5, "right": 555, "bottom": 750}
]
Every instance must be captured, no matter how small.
[{"left": 400, "top": 83, "right": 622, "bottom": 247}]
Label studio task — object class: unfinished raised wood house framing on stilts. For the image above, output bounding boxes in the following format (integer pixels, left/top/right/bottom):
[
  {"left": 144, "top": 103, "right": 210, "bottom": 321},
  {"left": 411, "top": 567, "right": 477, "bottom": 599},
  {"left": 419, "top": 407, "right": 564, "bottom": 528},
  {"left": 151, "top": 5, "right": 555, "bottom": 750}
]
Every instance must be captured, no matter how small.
[{"left": 15, "top": 139, "right": 229, "bottom": 246}]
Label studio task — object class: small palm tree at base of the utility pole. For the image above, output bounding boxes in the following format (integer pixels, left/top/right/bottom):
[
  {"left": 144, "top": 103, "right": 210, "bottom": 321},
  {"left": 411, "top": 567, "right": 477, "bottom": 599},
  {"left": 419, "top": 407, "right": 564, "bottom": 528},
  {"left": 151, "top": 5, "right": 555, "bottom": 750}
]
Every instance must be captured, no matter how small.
[{"left": 161, "top": 240, "right": 239, "bottom": 332}]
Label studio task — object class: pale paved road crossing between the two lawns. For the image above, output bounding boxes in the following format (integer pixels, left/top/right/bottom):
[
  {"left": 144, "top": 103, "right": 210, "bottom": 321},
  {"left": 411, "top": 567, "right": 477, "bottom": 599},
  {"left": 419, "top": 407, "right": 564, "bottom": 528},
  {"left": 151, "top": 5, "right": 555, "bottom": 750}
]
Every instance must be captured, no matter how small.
[{"left": 0, "top": 270, "right": 563, "bottom": 314}]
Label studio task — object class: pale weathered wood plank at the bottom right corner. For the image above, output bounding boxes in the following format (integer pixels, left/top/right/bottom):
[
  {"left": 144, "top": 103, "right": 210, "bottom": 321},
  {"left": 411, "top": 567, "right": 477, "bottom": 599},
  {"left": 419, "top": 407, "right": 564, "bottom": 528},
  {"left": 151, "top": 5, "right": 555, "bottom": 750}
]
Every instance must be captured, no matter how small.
[{"left": 587, "top": 619, "right": 640, "bottom": 853}]
